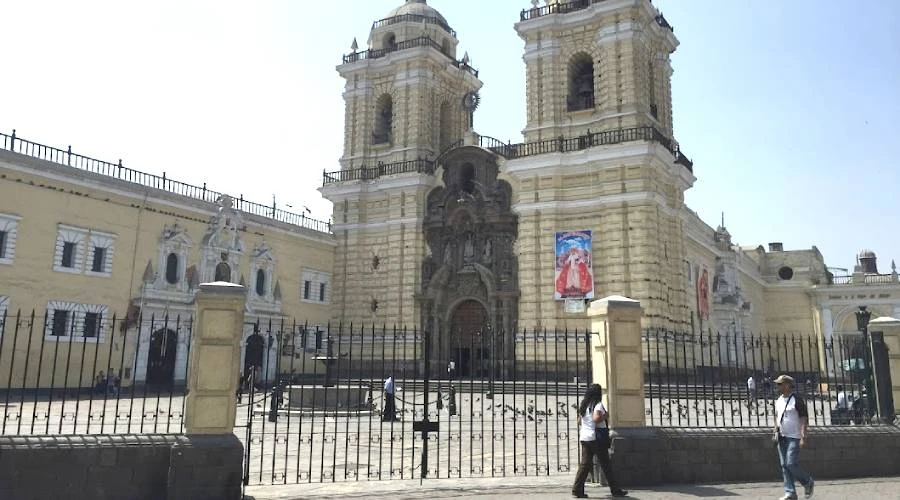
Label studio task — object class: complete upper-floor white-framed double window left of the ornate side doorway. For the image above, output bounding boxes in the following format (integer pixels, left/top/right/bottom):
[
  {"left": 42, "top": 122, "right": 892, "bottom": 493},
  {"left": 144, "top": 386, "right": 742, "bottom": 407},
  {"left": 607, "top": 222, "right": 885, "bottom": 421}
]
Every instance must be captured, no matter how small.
[{"left": 53, "top": 224, "right": 116, "bottom": 276}]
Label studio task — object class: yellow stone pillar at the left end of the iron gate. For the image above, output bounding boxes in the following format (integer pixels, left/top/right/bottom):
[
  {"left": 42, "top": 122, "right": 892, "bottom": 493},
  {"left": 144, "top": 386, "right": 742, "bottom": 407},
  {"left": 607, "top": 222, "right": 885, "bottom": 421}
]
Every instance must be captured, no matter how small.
[{"left": 185, "top": 282, "right": 246, "bottom": 435}]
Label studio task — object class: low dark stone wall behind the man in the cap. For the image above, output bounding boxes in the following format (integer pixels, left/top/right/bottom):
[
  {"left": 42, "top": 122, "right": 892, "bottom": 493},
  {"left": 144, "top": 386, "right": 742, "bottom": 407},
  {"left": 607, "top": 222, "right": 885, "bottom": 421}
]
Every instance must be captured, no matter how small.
[{"left": 612, "top": 426, "right": 900, "bottom": 487}]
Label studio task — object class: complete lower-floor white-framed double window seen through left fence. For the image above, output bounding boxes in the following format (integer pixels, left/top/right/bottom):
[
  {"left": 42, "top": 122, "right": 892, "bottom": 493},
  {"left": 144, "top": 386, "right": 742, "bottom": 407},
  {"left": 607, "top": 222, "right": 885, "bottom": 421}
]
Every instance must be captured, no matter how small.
[{"left": 44, "top": 300, "right": 109, "bottom": 342}]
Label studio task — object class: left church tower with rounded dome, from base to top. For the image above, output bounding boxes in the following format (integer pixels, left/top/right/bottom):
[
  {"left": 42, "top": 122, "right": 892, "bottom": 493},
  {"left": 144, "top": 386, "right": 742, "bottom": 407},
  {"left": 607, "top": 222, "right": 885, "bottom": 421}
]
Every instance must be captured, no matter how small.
[{"left": 321, "top": 0, "right": 481, "bottom": 327}]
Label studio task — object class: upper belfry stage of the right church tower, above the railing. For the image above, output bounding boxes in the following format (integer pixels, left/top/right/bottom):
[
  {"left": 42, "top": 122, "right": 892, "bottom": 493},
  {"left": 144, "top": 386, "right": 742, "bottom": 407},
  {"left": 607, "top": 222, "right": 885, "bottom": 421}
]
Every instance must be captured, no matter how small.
[{"left": 516, "top": 0, "right": 678, "bottom": 141}]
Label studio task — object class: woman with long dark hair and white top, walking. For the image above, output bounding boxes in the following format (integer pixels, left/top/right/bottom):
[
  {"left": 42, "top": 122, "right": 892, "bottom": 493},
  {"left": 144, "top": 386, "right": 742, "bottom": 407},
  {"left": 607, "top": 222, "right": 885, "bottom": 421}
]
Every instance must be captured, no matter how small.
[{"left": 572, "top": 384, "right": 628, "bottom": 498}]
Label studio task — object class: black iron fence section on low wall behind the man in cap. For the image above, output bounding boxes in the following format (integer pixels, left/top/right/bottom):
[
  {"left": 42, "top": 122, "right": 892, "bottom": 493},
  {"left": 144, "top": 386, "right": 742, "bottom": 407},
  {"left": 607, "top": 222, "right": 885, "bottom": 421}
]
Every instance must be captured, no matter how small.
[{"left": 643, "top": 330, "right": 875, "bottom": 427}]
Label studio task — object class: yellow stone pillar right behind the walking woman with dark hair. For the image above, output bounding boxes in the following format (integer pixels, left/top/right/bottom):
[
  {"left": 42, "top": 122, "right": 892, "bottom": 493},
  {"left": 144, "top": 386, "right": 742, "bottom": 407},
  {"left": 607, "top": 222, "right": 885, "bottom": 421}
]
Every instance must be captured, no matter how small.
[{"left": 588, "top": 295, "right": 645, "bottom": 428}]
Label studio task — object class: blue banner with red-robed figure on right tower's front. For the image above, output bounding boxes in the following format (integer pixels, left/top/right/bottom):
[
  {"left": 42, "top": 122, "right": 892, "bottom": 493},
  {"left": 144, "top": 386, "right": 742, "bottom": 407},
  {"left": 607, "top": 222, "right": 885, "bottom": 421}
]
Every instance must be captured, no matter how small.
[{"left": 553, "top": 230, "right": 594, "bottom": 300}]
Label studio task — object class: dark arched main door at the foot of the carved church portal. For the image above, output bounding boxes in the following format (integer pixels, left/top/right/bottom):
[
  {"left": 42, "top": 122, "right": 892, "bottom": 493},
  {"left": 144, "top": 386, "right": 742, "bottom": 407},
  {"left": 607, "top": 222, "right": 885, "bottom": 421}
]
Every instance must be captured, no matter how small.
[{"left": 448, "top": 299, "right": 490, "bottom": 377}]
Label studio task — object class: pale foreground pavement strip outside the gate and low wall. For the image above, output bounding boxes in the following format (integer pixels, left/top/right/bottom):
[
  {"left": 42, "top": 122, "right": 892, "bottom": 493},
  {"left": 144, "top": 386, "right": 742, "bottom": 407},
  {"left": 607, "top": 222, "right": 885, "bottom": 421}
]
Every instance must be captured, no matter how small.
[{"left": 247, "top": 474, "right": 900, "bottom": 500}]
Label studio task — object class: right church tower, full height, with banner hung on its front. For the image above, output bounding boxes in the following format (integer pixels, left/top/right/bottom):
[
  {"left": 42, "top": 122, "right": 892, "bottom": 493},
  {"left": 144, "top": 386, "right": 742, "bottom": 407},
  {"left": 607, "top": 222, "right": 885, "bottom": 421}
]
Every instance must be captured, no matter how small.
[{"left": 505, "top": 0, "right": 695, "bottom": 328}]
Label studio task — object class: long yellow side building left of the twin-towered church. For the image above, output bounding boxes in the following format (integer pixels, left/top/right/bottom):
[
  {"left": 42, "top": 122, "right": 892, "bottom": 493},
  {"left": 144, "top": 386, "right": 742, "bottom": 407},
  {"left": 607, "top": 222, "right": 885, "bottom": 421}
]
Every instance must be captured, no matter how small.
[{"left": 0, "top": 133, "right": 334, "bottom": 387}]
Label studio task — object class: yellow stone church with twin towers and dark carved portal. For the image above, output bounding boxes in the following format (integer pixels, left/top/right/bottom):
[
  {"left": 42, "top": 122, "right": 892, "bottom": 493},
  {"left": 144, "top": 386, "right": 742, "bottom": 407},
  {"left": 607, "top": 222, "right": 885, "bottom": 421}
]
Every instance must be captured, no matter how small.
[{"left": 321, "top": 0, "right": 900, "bottom": 372}]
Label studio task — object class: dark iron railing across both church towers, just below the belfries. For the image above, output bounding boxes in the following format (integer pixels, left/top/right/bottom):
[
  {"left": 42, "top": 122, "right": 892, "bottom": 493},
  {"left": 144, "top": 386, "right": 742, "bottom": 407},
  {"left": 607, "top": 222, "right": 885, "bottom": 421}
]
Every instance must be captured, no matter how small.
[{"left": 323, "top": 127, "right": 694, "bottom": 185}]
